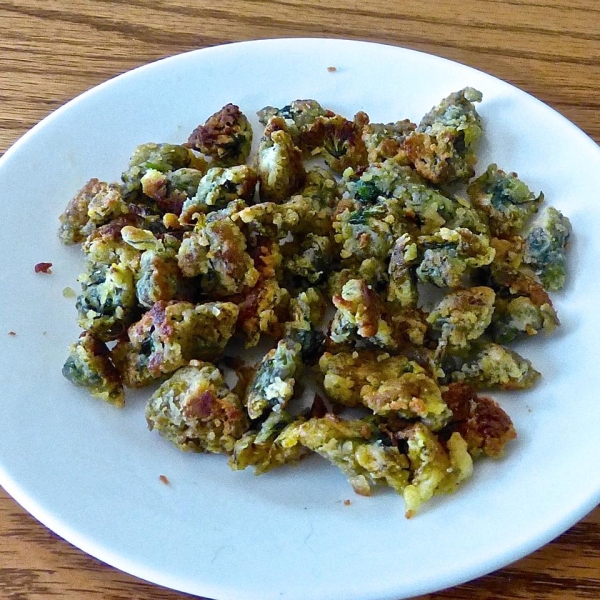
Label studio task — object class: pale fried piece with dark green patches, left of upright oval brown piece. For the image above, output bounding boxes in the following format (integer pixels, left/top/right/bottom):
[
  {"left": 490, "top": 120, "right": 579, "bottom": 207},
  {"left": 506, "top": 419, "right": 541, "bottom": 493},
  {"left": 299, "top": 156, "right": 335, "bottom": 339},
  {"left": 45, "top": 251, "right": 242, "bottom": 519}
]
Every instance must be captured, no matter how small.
[{"left": 179, "top": 165, "right": 257, "bottom": 224}]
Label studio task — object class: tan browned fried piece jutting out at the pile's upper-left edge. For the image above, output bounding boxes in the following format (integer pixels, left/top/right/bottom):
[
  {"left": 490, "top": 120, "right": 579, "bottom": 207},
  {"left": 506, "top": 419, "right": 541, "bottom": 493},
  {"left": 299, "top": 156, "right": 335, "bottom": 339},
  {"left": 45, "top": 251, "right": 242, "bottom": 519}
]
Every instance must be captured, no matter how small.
[{"left": 58, "top": 179, "right": 129, "bottom": 244}]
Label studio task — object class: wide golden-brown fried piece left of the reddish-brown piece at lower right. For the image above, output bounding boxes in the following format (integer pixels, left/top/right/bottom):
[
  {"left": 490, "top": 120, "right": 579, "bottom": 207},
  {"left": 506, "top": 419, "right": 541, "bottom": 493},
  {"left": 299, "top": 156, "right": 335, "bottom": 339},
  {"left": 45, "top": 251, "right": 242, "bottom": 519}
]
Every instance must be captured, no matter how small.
[{"left": 319, "top": 350, "right": 452, "bottom": 430}]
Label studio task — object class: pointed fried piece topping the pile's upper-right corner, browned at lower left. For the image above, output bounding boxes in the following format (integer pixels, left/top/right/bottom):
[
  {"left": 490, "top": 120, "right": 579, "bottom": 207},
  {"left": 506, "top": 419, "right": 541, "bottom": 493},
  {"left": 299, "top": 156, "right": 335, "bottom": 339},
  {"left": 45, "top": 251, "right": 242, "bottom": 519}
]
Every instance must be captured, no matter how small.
[{"left": 402, "top": 88, "right": 483, "bottom": 185}]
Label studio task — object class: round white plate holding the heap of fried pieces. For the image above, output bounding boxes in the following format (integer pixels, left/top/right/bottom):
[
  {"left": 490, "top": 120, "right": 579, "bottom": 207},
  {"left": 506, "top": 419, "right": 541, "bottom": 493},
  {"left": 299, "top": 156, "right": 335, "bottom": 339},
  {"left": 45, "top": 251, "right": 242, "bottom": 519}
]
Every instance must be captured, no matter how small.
[{"left": 0, "top": 39, "right": 600, "bottom": 600}]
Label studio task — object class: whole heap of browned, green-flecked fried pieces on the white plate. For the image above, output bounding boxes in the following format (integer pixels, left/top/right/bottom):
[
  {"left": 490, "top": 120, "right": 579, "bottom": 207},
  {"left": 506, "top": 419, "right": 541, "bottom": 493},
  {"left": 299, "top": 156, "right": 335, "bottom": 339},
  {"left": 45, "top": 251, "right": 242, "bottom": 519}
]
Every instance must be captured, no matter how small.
[{"left": 59, "top": 88, "right": 571, "bottom": 516}]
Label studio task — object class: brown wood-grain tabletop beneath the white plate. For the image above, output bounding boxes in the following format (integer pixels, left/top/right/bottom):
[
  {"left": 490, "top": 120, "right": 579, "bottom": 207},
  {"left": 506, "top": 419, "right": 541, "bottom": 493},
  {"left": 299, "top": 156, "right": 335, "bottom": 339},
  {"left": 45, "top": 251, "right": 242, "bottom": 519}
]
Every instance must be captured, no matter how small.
[{"left": 0, "top": 0, "right": 600, "bottom": 600}]
